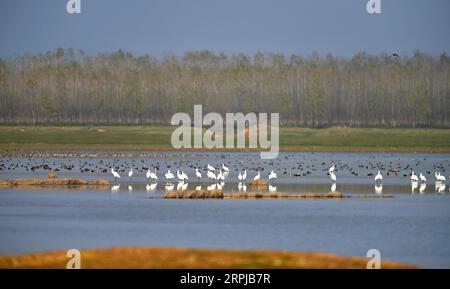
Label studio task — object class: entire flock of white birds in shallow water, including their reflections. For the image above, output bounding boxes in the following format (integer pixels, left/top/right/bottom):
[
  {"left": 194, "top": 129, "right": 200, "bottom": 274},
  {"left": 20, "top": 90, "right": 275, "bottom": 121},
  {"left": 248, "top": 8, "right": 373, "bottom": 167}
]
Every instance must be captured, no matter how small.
[{"left": 111, "top": 164, "right": 450, "bottom": 193}]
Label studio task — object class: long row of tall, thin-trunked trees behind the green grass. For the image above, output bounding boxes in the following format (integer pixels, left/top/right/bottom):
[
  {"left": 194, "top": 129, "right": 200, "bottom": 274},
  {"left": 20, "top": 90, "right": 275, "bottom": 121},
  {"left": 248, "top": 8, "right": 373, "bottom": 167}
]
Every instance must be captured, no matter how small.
[{"left": 0, "top": 49, "right": 450, "bottom": 127}]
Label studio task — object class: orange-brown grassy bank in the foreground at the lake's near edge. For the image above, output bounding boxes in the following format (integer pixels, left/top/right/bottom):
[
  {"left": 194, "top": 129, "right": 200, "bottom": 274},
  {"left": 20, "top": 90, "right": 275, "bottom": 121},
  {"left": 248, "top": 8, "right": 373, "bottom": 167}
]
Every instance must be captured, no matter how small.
[{"left": 0, "top": 248, "right": 416, "bottom": 269}]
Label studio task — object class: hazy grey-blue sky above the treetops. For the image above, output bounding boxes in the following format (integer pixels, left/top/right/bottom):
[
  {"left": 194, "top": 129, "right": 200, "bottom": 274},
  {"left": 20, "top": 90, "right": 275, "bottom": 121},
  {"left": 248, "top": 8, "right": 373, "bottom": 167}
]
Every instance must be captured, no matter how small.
[{"left": 0, "top": 0, "right": 450, "bottom": 57}]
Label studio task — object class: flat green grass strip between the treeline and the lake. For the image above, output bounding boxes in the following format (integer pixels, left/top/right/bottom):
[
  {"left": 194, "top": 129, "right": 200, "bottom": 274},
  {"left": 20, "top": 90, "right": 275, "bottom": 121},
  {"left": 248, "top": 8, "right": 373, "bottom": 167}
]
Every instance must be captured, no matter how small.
[{"left": 0, "top": 126, "right": 450, "bottom": 152}]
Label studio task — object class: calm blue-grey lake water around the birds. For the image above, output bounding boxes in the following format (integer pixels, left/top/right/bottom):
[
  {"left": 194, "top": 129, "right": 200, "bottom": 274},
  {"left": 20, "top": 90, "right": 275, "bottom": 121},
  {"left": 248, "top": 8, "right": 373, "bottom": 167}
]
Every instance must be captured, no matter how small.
[{"left": 0, "top": 152, "right": 450, "bottom": 268}]
